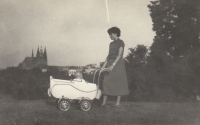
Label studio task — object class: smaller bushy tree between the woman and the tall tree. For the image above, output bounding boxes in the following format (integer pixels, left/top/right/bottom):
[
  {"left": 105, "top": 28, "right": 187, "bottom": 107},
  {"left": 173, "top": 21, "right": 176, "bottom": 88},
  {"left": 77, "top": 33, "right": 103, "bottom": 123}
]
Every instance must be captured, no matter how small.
[{"left": 125, "top": 45, "right": 148, "bottom": 101}]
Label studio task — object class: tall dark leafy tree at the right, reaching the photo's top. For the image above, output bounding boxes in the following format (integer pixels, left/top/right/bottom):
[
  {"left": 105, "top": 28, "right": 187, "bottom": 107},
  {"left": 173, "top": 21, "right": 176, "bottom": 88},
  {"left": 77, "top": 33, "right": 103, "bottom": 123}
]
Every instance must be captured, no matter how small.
[{"left": 146, "top": 0, "right": 200, "bottom": 99}]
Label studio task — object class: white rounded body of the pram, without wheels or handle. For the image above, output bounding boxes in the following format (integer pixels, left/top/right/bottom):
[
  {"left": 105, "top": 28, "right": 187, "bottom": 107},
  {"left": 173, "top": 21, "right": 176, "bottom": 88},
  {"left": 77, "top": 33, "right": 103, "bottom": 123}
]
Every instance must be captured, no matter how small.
[{"left": 48, "top": 76, "right": 101, "bottom": 100}]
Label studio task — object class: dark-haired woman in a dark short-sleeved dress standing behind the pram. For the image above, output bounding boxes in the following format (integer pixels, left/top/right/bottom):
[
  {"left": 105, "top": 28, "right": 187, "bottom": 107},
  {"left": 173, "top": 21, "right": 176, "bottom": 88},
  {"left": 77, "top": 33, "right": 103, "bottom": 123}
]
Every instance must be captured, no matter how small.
[{"left": 101, "top": 27, "right": 129, "bottom": 108}]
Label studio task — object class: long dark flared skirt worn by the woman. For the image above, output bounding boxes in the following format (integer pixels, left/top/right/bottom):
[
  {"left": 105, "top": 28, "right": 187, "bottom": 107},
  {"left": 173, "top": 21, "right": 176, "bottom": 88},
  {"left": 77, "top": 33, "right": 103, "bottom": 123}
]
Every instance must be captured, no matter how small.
[{"left": 103, "top": 58, "right": 129, "bottom": 96}]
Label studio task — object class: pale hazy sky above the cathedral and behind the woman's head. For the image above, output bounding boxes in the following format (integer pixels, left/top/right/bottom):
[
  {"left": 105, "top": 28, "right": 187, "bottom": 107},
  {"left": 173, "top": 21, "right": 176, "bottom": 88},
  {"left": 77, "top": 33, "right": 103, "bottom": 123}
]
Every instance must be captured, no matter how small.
[{"left": 0, "top": 0, "right": 155, "bottom": 68}]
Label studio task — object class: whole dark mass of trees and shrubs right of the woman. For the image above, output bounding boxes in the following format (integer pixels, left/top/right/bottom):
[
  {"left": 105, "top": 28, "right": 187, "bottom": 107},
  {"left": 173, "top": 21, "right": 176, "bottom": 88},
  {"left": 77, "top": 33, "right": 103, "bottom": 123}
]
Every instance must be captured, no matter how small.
[{"left": 126, "top": 0, "right": 200, "bottom": 101}]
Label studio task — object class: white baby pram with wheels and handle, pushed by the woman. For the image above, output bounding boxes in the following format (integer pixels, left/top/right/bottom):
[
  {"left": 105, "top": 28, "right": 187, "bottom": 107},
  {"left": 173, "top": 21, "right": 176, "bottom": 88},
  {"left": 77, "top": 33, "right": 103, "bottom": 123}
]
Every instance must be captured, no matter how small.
[{"left": 48, "top": 69, "right": 103, "bottom": 111}]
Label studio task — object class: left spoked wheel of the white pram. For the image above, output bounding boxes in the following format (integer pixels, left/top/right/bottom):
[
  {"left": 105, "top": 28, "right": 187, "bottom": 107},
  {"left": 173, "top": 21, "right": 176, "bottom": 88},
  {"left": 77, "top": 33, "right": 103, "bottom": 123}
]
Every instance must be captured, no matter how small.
[{"left": 58, "top": 99, "right": 71, "bottom": 111}]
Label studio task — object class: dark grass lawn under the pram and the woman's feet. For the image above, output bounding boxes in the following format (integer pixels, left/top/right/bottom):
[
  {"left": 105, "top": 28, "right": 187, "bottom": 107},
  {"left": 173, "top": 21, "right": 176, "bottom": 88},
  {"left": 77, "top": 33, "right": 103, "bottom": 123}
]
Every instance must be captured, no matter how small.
[{"left": 0, "top": 95, "right": 200, "bottom": 125}]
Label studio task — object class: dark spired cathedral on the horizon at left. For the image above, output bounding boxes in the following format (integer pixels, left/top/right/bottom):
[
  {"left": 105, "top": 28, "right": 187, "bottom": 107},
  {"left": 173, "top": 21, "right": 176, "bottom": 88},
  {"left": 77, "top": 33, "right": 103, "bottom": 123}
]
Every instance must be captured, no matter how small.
[{"left": 18, "top": 47, "right": 48, "bottom": 72}]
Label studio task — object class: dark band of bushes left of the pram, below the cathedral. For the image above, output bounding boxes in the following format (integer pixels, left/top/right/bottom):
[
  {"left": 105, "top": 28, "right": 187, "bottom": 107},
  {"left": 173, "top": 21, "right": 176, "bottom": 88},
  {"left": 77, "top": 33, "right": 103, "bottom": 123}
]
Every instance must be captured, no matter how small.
[{"left": 0, "top": 67, "right": 70, "bottom": 100}]
